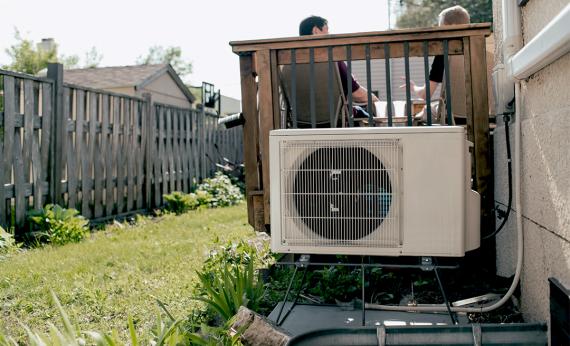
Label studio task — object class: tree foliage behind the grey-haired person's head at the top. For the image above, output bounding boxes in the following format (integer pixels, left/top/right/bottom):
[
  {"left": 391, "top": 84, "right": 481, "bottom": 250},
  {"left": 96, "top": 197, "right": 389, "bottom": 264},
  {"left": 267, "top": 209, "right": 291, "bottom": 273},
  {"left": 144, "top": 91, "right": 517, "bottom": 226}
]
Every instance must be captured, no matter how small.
[{"left": 396, "top": 0, "right": 493, "bottom": 28}]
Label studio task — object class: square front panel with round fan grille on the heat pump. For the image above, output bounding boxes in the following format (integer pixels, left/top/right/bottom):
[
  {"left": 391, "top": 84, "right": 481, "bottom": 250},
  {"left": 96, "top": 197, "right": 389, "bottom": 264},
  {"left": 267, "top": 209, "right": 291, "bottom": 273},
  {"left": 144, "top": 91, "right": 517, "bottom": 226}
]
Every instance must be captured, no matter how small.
[{"left": 281, "top": 139, "right": 401, "bottom": 247}]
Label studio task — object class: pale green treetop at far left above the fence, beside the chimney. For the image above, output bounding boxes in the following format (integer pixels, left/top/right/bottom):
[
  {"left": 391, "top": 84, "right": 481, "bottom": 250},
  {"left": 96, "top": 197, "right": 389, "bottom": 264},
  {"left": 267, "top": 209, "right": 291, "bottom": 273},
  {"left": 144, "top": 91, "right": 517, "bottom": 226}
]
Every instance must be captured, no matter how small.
[{"left": 2, "top": 29, "right": 103, "bottom": 74}]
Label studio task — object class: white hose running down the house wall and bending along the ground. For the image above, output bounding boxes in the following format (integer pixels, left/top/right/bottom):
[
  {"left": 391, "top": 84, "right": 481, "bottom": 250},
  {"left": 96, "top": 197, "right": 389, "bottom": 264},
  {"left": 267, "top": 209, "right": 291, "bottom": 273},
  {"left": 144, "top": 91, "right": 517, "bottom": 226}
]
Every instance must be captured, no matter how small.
[{"left": 366, "top": 83, "right": 524, "bottom": 313}]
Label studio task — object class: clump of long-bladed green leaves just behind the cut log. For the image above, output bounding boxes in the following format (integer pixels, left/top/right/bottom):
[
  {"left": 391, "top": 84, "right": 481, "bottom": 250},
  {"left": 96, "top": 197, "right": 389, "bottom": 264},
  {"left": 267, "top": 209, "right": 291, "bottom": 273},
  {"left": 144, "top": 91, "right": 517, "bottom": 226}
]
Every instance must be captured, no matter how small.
[{"left": 195, "top": 261, "right": 264, "bottom": 321}]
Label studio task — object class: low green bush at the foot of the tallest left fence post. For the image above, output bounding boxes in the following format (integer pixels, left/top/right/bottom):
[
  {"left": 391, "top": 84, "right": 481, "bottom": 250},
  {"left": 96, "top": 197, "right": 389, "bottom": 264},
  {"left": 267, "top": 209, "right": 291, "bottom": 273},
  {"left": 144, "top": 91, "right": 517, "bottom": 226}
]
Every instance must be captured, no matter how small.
[{"left": 29, "top": 204, "right": 89, "bottom": 245}]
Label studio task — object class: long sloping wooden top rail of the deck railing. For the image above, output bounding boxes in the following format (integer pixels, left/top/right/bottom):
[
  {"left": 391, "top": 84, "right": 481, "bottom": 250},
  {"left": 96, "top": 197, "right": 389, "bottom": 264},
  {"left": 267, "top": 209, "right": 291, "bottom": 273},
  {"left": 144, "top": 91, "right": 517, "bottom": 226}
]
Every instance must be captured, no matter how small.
[{"left": 230, "top": 23, "right": 491, "bottom": 54}]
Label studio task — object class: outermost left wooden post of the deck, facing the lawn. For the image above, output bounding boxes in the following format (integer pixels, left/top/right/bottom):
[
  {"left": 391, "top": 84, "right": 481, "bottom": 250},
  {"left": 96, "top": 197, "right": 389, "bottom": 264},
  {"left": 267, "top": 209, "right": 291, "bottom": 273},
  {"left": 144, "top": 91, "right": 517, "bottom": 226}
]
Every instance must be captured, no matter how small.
[{"left": 239, "top": 55, "right": 261, "bottom": 227}]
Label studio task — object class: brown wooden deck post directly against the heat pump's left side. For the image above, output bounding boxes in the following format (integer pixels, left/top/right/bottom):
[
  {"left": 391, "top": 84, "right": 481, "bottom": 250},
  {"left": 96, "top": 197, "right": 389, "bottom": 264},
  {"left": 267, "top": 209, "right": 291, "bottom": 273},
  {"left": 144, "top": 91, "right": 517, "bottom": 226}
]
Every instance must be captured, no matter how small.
[{"left": 257, "top": 50, "right": 275, "bottom": 225}]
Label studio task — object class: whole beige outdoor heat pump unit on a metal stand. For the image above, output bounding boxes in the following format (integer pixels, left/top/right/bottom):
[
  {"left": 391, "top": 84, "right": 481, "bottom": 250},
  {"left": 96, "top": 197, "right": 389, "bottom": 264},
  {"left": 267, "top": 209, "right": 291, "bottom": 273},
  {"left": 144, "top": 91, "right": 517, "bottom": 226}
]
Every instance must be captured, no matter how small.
[{"left": 269, "top": 126, "right": 480, "bottom": 257}]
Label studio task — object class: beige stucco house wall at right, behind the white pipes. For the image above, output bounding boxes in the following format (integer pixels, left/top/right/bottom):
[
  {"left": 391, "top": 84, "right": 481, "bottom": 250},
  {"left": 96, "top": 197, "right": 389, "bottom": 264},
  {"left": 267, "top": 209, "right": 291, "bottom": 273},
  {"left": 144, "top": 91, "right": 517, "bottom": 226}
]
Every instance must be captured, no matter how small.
[{"left": 493, "top": 0, "right": 570, "bottom": 322}]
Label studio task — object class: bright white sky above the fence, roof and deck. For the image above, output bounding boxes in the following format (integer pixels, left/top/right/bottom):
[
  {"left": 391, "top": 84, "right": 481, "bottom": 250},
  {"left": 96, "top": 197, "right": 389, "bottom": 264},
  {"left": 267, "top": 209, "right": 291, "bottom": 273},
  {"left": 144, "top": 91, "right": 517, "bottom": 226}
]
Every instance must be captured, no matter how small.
[{"left": 0, "top": 0, "right": 393, "bottom": 99}]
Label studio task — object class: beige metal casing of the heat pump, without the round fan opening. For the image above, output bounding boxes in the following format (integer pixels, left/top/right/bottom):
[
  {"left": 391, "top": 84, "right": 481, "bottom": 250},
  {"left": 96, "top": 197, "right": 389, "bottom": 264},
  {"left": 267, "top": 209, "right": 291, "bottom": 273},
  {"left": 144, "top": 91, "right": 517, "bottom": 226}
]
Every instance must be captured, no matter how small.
[{"left": 269, "top": 126, "right": 480, "bottom": 257}]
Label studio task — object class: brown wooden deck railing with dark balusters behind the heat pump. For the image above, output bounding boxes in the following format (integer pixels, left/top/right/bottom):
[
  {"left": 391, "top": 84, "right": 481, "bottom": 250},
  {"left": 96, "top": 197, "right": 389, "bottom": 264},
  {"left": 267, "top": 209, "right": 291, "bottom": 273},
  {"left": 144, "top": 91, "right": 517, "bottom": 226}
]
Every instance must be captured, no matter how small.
[{"left": 230, "top": 24, "right": 493, "bottom": 230}]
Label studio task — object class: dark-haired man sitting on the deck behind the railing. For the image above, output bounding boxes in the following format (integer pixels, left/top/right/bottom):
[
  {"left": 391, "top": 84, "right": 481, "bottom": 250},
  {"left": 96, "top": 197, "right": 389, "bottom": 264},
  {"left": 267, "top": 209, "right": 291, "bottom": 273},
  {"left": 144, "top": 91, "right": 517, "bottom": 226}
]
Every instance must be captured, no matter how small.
[{"left": 299, "top": 16, "right": 378, "bottom": 103}]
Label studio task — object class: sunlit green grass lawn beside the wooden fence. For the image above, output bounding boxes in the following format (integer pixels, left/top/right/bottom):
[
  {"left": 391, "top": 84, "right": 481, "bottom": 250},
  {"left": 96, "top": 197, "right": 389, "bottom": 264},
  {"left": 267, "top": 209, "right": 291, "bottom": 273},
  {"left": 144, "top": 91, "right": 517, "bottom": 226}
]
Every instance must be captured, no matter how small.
[{"left": 0, "top": 203, "right": 254, "bottom": 341}]
